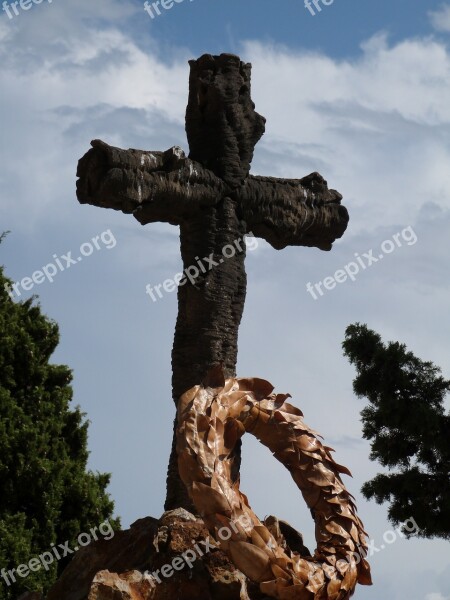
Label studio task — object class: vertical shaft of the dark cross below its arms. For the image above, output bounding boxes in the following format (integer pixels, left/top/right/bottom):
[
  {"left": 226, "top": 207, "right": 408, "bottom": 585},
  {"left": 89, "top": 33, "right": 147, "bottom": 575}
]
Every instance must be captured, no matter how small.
[{"left": 165, "top": 198, "right": 246, "bottom": 510}]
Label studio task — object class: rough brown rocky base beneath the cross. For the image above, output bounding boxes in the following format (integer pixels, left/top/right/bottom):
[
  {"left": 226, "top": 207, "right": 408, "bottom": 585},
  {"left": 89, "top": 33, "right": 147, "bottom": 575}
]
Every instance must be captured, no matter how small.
[{"left": 20, "top": 509, "right": 282, "bottom": 600}]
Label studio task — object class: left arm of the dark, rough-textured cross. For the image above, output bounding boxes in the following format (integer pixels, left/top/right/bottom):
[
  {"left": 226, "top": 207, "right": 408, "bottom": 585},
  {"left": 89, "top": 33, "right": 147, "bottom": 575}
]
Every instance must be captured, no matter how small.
[{"left": 77, "top": 140, "right": 226, "bottom": 225}]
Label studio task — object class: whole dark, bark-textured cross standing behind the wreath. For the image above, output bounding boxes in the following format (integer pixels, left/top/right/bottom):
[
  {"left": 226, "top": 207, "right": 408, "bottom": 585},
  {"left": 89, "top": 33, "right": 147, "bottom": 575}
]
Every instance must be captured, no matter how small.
[{"left": 77, "top": 54, "right": 348, "bottom": 510}]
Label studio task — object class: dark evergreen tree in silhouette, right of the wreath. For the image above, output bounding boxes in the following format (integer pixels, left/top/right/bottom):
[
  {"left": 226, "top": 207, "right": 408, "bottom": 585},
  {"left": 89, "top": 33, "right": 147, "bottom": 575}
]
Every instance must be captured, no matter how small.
[{"left": 343, "top": 323, "right": 450, "bottom": 539}]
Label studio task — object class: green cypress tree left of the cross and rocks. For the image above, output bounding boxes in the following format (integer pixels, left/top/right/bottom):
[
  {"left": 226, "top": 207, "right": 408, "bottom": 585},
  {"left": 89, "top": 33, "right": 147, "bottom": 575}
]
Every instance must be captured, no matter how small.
[{"left": 0, "top": 236, "right": 119, "bottom": 600}]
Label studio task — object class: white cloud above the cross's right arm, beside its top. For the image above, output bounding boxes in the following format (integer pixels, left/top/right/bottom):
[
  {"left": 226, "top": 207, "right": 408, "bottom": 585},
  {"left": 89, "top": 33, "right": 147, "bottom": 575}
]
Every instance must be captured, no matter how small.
[{"left": 241, "top": 36, "right": 450, "bottom": 233}]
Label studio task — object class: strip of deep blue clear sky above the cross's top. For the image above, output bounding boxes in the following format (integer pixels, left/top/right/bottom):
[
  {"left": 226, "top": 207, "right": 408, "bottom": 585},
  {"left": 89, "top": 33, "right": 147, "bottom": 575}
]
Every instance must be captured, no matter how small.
[{"left": 136, "top": 0, "right": 446, "bottom": 58}]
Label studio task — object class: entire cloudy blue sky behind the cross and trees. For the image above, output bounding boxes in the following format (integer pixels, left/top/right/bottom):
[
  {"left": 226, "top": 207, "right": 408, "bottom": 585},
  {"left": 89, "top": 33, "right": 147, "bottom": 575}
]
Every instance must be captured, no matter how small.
[{"left": 0, "top": 0, "right": 450, "bottom": 600}]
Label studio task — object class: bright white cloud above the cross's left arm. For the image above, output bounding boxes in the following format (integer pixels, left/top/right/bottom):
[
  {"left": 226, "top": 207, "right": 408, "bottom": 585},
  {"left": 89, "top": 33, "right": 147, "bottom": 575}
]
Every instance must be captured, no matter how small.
[{"left": 0, "top": 14, "right": 188, "bottom": 227}]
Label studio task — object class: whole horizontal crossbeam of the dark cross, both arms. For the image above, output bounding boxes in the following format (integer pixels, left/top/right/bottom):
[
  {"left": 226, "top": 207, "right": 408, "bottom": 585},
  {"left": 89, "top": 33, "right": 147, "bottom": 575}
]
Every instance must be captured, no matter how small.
[{"left": 77, "top": 140, "right": 349, "bottom": 250}]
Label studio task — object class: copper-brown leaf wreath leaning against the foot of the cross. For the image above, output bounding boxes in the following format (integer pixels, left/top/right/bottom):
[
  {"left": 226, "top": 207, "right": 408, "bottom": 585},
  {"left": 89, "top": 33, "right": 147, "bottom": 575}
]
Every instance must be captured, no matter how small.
[{"left": 177, "top": 376, "right": 371, "bottom": 600}]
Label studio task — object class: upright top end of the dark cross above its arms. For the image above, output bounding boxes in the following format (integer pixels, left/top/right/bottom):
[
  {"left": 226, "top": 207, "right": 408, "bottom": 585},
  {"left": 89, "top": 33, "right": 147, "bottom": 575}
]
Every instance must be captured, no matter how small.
[{"left": 186, "top": 54, "right": 266, "bottom": 188}]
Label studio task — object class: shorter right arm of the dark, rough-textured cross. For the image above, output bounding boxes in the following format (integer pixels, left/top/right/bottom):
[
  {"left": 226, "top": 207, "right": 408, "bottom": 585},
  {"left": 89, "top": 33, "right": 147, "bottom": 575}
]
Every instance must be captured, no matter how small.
[{"left": 239, "top": 173, "right": 349, "bottom": 250}]
